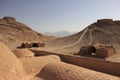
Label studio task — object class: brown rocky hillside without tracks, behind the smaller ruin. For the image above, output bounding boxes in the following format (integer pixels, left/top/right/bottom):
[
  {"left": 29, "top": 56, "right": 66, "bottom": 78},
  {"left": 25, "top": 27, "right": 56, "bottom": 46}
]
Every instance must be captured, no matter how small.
[{"left": 0, "top": 17, "right": 52, "bottom": 49}]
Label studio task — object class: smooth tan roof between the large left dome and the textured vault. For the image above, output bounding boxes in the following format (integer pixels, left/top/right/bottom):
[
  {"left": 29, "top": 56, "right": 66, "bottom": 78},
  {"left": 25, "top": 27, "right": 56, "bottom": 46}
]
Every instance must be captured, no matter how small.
[{"left": 20, "top": 55, "right": 60, "bottom": 76}]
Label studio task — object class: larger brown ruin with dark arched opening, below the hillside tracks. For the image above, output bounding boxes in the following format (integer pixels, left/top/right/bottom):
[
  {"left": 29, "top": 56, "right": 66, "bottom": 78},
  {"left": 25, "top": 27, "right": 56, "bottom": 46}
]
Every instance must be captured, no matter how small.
[{"left": 77, "top": 46, "right": 115, "bottom": 58}]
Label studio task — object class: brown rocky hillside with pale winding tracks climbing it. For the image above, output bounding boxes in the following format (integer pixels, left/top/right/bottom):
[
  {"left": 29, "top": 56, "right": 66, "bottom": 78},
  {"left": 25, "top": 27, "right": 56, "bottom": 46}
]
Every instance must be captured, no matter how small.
[{"left": 49, "top": 19, "right": 120, "bottom": 53}]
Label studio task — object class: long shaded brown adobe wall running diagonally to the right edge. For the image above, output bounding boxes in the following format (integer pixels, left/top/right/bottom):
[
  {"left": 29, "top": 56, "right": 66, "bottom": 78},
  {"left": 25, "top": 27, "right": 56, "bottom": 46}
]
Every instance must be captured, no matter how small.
[{"left": 33, "top": 51, "right": 120, "bottom": 76}]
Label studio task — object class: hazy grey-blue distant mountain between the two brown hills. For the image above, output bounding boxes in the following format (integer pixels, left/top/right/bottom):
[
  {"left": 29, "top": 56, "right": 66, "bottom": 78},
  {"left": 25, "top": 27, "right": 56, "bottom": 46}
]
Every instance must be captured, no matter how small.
[{"left": 44, "top": 31, "right": 75, "bottom": 37}]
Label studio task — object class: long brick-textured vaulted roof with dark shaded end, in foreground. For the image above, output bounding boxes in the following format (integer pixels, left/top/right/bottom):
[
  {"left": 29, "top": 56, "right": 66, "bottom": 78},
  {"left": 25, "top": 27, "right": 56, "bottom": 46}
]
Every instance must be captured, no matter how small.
[{"left": 38, "top": 62, "right": 120, "bottom": 80}]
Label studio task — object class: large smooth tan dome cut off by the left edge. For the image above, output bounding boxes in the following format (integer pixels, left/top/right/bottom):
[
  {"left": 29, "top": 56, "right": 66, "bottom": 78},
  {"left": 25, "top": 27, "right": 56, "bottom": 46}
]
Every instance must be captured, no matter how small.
[{"left": 0, "top": 42, "right": 25, "bottom": 80}]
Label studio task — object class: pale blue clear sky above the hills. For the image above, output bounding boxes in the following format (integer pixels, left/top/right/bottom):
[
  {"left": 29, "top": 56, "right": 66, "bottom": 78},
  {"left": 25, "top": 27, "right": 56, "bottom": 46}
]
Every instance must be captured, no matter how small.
[{"left": 0, "top": 0, "right": 120, "bottom": 32}]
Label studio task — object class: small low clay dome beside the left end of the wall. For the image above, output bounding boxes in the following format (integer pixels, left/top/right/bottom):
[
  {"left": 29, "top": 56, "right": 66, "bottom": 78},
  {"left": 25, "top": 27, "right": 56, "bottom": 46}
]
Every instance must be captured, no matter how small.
[{"left": 13, "top": 49, "right": 34, "bottom": 58}]
